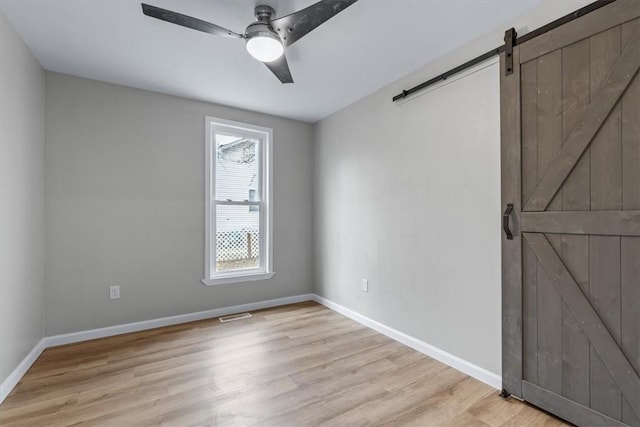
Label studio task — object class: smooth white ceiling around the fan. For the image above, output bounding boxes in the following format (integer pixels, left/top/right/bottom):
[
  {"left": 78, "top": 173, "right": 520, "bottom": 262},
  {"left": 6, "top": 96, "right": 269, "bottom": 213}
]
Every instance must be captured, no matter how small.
[{"left": 0, "top": 0, "right": 539, "bottom": 122}]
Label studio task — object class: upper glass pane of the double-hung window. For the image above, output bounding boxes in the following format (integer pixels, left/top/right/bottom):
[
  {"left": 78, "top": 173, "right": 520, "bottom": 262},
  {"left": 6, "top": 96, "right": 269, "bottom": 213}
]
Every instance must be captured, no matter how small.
[{"left": 215, "top": 134, "right": 260, "bottom": 201}]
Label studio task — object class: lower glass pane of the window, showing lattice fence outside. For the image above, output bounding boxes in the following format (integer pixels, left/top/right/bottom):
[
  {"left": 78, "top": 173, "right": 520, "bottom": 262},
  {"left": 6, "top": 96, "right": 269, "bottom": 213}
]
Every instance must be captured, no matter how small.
[{"left": 216, "top": 205, "right": 260, "bottom": 273}]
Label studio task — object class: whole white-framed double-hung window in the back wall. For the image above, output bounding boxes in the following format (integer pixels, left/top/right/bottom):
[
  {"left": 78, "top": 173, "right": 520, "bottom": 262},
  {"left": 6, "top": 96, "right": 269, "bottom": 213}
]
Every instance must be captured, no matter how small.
[{"left": 202, "top": 117, "right": 274, "bottom": 286}]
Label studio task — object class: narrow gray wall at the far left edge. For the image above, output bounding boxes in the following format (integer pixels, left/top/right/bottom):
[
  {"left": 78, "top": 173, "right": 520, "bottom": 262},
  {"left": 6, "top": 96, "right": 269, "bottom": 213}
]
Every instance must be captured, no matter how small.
[{"left": 0, "top": 12, "right": 45, "bottom": 382}]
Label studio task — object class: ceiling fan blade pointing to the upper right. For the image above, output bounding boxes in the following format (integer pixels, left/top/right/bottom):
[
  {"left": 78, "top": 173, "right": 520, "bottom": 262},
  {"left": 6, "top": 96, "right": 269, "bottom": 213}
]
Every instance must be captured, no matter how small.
[{"left": 271, "top": 0, "right": 357, "bottom": 46}]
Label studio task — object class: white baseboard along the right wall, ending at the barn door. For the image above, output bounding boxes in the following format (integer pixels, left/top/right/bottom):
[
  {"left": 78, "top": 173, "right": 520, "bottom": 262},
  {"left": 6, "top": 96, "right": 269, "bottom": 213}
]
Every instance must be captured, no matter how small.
[{"left": 313, "top": 295, "right": 502, "bottom": 390}]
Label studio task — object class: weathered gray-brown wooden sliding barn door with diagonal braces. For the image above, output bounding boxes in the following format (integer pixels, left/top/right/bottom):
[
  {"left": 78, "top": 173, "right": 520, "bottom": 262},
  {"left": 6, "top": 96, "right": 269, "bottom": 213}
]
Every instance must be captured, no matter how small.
[{"left": 501, "top": 0, "right": 640, "bottom": 426}]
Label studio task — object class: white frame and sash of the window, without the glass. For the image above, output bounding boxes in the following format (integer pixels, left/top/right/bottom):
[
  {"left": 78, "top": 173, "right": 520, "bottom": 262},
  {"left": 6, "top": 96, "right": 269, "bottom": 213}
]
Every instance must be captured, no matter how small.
[{"left": 202, "top": 116, "right": 275, "bottom": 286}]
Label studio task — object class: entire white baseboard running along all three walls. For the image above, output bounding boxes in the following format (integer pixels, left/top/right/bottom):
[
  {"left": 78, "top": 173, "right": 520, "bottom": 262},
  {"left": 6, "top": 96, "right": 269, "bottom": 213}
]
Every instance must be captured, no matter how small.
[{"left": 0, "top": 294, "right": 502, "bottom": 403}]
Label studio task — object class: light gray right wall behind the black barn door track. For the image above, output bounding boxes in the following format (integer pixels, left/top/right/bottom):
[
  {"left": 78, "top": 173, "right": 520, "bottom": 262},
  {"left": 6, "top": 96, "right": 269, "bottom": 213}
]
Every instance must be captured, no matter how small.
[{"left": 314, "top": 0, "right": 589, "bottom": 374}]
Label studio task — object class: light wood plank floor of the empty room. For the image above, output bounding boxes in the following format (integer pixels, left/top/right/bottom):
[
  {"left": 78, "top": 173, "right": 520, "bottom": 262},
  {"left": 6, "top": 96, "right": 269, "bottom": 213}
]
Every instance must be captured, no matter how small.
[{"left": 0, "top": 303, "right": 562, "bottom": 427}]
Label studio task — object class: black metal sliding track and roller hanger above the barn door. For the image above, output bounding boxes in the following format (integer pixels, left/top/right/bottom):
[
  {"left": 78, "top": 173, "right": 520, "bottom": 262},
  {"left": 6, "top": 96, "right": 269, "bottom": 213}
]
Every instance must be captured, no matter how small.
[{"left": 393, "top": 0, "right": 616, "bottom": 102}]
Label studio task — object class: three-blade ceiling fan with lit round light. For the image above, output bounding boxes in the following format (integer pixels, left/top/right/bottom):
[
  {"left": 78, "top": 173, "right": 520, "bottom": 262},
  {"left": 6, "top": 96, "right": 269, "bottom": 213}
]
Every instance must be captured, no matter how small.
[{"left": 142, "top": 0, "right": 357, "bottom": 83}]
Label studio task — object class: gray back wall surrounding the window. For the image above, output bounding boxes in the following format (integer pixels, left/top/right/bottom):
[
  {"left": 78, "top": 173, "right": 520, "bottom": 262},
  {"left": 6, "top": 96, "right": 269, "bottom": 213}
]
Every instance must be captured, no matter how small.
[{"left": 45, "top": 72, "right": 313, "bottom": 335}]
